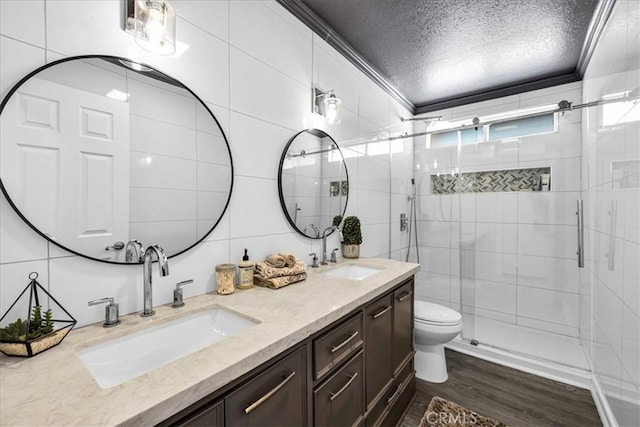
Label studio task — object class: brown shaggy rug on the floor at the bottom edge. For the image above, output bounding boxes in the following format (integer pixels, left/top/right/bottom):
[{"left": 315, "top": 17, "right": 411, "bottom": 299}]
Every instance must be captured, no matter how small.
[{"left": 419, "top": 396, "right": 506, "bottom": 427}]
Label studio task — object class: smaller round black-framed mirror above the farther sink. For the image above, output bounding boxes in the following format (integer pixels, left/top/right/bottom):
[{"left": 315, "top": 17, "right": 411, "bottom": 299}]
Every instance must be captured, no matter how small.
[{"left": 278, "top": 129, "right": 349, "bottom": 239}]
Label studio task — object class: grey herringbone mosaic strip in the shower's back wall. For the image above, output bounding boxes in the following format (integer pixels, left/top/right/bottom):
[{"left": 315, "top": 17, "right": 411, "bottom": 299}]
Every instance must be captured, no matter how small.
[{"left": 431, "top": 167, "right": 551, "bottom": 194}]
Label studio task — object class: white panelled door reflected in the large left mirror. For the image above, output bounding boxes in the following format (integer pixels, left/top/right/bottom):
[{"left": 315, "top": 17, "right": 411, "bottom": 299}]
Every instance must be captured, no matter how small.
[{"left": 2, "top": 79, "right": 129, "bottom": 257}]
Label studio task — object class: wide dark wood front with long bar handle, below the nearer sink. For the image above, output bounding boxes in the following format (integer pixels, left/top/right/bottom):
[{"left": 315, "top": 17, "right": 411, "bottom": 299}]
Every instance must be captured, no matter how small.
[{"left": 225, "top": 347, "right": 307, "bottom": 426}]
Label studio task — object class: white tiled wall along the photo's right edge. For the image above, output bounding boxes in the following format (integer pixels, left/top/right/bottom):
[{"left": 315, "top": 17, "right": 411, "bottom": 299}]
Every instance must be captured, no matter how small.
[{"left": 580, "top": 0, "right": 640, "bottom": 426}]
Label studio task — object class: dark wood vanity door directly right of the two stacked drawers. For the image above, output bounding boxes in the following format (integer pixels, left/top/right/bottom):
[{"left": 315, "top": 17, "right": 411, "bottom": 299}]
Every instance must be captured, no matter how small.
[{"left": 364, "top": 293, "right": 393, "bottom": 409}]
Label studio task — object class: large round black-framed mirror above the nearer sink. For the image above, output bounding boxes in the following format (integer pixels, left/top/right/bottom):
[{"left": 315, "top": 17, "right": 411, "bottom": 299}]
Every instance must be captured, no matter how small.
[{"left": 0, "top": 56, "right": 233, "bottom": 263}]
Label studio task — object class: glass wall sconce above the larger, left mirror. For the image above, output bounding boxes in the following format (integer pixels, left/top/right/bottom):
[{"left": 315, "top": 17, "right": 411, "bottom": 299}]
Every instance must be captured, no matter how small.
[{"left": 125, "top": 0, "right": 176, "bottom": 55}]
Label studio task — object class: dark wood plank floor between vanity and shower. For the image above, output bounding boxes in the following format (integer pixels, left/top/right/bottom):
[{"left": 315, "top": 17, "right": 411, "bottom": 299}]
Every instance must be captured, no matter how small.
[{"left": 400, "top": 350, "right": 602, "bottom": 427}]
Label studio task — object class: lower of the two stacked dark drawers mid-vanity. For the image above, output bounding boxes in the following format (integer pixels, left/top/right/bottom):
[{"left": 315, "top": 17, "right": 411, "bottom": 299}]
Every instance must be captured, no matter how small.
[{"left": 313, "top": 351, "right": 364, "bottom": 426}]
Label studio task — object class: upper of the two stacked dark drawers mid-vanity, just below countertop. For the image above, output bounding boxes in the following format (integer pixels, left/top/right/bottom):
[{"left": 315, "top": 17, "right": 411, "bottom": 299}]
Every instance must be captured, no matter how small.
[{"left": 313, "top": 313, "right": 364, "bottom": 380}]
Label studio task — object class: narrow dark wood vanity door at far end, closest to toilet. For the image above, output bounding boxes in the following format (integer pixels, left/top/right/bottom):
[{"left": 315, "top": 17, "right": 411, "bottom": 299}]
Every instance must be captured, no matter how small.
[{"left": 393, "top": 280, "right": 413, "bottom": 372}]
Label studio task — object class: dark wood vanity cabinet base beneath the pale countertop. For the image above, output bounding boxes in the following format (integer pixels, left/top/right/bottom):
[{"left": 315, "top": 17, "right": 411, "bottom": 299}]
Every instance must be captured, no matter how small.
[{"left": 161, "top": 278, "right": 415, "bottom": 427}]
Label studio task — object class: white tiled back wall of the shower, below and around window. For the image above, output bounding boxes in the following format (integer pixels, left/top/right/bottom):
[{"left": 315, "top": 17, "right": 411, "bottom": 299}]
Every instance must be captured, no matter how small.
[{"left": 415, "top": 82, "right": 586, "bottom": 368}]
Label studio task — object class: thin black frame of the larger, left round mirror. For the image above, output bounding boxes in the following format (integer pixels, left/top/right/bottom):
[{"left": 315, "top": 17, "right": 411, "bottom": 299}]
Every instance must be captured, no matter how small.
[{"left": 0, "top": 55, "right": 235, "bottom": 265}]
